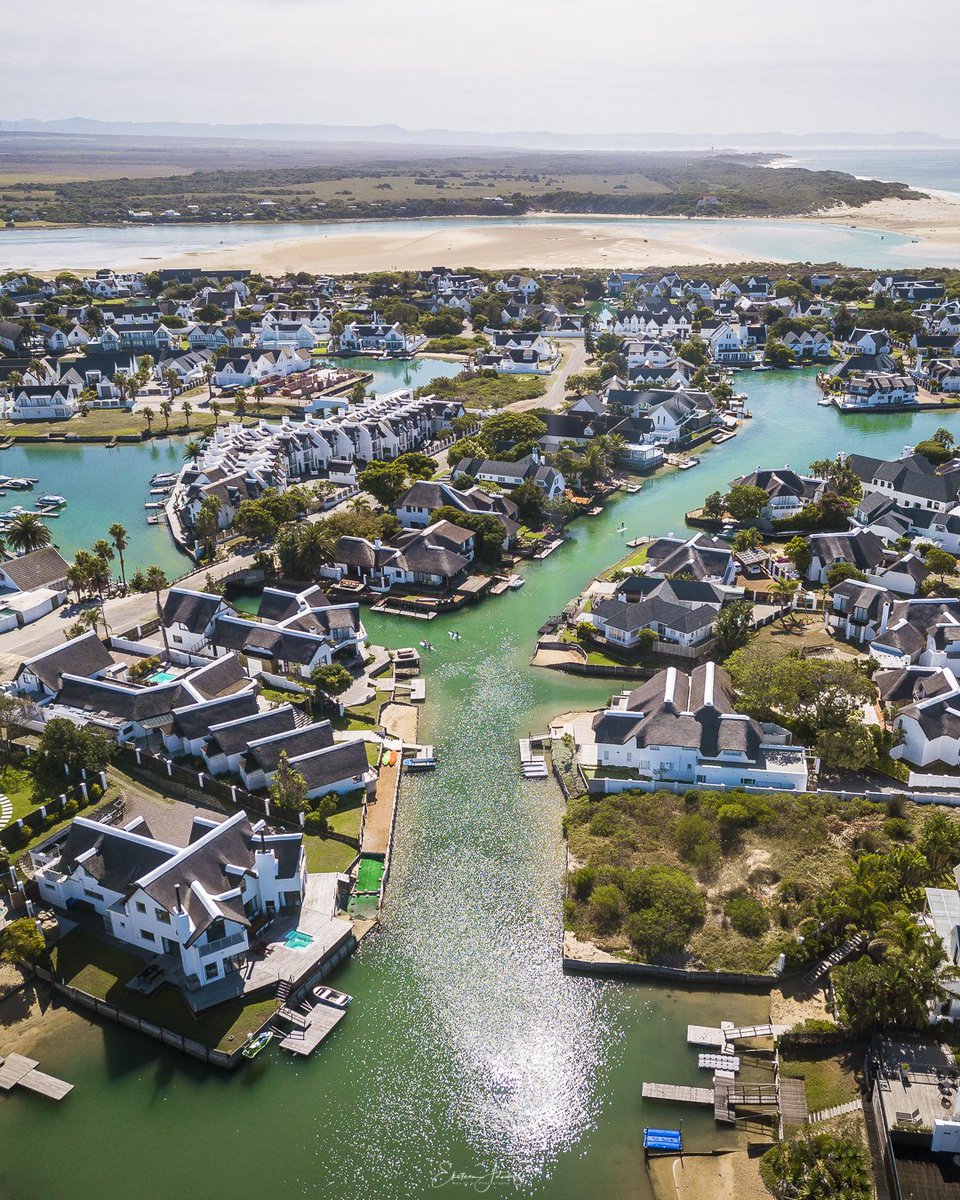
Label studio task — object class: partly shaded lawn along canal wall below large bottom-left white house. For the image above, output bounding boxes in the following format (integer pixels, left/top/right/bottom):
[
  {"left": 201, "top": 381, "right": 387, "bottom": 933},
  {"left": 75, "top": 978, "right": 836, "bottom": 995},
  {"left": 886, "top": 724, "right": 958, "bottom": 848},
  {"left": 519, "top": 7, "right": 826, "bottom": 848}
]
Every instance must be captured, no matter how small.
[{"left": 50, "top": 928, "right": 276, "bottom": 1052}]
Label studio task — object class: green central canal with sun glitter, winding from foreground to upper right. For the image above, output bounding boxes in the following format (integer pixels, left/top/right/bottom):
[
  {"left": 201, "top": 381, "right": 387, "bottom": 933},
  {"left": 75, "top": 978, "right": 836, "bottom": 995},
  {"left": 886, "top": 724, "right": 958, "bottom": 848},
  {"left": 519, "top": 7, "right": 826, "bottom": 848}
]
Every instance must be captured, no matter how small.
[{"left": 0, "top": 372, "right": 960, "bottom": 1200}]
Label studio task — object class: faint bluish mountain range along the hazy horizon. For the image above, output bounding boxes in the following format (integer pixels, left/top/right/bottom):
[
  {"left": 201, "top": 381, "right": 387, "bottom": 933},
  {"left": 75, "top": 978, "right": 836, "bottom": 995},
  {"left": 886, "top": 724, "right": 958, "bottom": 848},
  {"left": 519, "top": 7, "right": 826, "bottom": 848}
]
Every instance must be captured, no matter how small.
[{"left": 0, "top": 116, "right": 960, "bottom": 151}]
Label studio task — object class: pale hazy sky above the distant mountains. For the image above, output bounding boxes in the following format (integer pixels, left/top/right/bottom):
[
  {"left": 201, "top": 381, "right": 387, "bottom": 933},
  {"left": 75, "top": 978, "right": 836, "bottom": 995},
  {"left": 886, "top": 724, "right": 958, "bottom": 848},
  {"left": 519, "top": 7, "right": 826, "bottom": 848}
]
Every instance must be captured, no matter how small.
[{"left": 0, "top": 0, "right": 960, "bottom": 134}]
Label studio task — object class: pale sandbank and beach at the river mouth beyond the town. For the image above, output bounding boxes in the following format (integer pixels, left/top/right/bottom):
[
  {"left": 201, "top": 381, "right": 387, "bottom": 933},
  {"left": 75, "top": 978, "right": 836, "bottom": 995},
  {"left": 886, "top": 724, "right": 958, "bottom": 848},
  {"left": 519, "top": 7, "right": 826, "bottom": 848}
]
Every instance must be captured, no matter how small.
[{"left": 144, "top": 196, "right": 960, "bottom": 274}]
